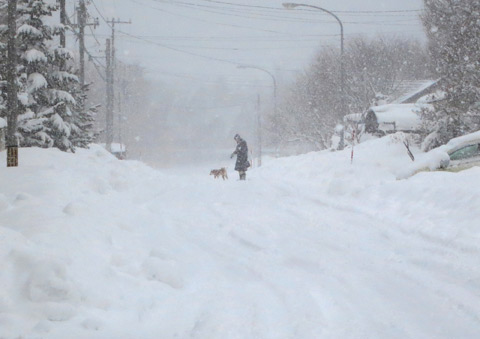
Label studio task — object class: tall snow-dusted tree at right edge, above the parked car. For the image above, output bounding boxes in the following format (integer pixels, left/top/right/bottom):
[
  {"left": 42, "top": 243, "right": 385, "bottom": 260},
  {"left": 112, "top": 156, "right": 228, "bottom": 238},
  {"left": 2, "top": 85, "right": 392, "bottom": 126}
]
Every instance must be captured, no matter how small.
[{"left": 423, "top": 0, "right": 480, "bottom": 149}]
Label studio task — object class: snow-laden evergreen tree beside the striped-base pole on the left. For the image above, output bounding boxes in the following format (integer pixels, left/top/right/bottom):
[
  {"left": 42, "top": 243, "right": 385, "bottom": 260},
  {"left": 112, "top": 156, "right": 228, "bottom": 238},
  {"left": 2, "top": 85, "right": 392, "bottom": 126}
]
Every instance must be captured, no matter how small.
[{"left": 0, "top": 0, "right": 95, "bottom": 152}]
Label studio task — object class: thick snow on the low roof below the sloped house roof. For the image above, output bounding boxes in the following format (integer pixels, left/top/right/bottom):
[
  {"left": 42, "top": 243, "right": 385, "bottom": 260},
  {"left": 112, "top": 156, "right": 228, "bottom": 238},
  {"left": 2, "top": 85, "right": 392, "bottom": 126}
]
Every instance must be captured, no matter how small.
[{"left": 370, "top": 104, "right": 421, "bottom": 131}]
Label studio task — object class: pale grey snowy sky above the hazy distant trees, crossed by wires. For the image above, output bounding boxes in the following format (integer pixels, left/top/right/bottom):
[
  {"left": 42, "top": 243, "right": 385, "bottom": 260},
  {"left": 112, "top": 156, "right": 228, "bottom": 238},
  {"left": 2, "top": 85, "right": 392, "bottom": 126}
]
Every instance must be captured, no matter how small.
[{"left": 75, "top": 0, "right": 424, "bottom": 86}]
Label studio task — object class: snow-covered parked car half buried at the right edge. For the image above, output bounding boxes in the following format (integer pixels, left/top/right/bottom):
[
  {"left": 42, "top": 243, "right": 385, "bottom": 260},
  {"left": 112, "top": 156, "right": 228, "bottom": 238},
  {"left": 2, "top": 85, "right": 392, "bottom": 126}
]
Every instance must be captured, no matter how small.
[{"left": 439, "top": 131, "right": 480, "bottom": 170}]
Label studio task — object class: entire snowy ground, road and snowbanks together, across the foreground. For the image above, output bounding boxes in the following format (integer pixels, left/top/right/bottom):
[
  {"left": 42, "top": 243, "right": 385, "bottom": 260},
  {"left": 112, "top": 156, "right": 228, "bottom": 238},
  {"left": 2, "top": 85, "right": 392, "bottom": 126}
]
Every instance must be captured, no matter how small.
[{"left": 0, "top": 141, "right": 480, "bottom": 339}]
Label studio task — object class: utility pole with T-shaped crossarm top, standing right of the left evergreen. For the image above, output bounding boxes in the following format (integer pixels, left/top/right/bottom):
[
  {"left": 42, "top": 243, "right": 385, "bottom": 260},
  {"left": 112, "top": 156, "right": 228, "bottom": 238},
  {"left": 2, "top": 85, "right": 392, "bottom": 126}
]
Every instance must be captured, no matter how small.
[{"left": 105, "top": 19, "right": 132, "bottom": 152}]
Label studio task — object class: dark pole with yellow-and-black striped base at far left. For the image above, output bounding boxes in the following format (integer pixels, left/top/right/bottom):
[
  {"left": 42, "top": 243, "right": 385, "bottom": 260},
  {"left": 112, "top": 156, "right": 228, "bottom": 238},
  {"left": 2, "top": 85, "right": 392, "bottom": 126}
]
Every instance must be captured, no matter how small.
[{"left": 7, "top": 0, "right": 18, "bottom": 167}]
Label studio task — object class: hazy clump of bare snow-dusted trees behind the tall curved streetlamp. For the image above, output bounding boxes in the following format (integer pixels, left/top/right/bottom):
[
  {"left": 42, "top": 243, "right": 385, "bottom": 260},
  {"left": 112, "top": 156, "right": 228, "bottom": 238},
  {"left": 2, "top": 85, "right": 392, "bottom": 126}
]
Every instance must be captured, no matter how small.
[{"left": 269, "top": 37, "right": 429, "bottom": 150}]
